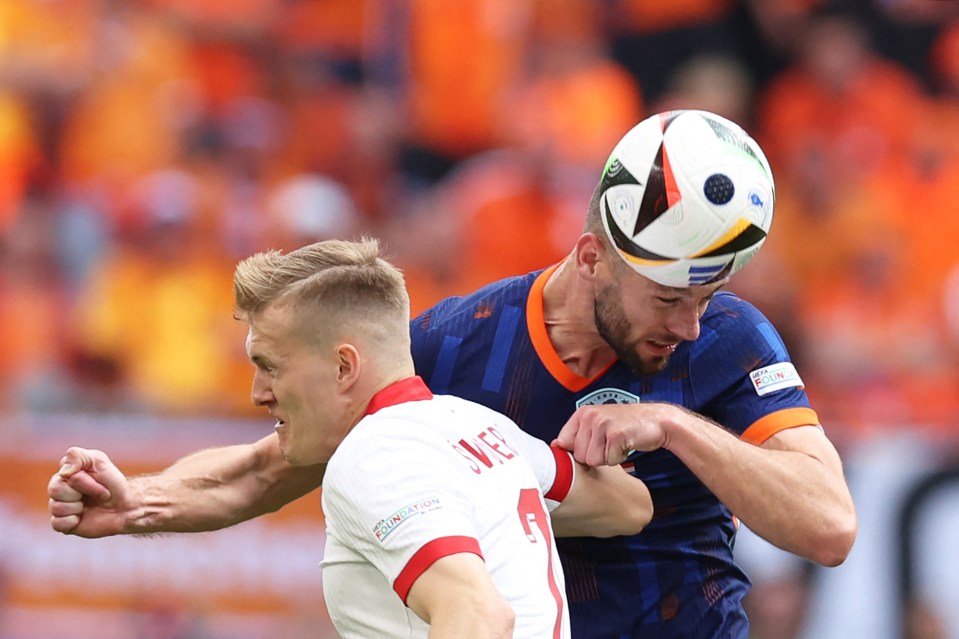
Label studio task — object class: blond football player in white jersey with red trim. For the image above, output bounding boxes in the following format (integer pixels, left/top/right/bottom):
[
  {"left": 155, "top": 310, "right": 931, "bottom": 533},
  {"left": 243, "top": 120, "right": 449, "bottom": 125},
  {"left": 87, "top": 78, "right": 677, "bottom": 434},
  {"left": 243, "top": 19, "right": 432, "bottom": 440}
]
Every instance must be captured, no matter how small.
[{"left": 52, "top": 239, "right": 652, "bottom": 639}]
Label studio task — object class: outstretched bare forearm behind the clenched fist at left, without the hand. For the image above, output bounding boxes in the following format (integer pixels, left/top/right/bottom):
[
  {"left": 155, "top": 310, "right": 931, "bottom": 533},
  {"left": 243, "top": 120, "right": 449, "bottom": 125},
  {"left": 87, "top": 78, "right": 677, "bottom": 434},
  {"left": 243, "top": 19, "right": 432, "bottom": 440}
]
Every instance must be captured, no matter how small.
[{"left": 124, "top": 438, "right": 325, "bottom": 534}]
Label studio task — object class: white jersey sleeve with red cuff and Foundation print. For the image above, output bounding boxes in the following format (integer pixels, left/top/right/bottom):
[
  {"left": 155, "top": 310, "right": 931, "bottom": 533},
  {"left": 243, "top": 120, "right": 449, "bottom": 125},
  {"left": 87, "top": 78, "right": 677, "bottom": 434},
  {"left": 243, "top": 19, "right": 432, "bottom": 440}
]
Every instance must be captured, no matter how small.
[{"left": 323, "top": 426, "right": 482, "bottom": 603}]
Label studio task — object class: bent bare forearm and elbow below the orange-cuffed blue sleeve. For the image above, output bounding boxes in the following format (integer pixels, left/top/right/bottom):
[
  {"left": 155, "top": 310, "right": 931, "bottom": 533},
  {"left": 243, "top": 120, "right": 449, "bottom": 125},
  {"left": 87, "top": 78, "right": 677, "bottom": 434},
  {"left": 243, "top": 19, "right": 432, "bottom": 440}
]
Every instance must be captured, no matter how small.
[{"left": 665, "top": 411, "right": 856, "bottom": 565}]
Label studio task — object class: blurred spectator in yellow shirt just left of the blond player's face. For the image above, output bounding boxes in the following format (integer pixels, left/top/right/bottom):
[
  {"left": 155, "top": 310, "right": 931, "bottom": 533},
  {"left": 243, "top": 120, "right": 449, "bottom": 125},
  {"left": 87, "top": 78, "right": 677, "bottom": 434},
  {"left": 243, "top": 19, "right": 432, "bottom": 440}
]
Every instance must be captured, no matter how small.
[{"left": 72, "top": 170, "right": 255, "bottom": 414}]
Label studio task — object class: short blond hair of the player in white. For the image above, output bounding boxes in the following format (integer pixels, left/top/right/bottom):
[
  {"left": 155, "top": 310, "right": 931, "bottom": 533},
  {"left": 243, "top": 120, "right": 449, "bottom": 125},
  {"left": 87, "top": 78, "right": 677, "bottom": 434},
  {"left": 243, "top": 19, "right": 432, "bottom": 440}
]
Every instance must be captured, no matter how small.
[{"left": 233, "top": 238, "right": 410, "bottom": 341}]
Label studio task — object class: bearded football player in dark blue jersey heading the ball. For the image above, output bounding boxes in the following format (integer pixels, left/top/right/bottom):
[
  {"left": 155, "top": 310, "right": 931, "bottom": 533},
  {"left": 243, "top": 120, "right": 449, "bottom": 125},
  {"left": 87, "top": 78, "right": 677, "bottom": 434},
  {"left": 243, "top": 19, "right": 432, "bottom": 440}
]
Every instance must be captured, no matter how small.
[{"left": 49, "top": 112, "right": 857, "bottom": 639}]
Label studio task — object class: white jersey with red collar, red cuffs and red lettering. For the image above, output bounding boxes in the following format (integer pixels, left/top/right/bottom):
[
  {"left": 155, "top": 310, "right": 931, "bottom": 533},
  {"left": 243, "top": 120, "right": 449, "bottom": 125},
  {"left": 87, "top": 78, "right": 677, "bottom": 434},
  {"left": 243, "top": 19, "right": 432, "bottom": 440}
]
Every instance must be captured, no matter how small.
[{"left": 322, "top": 377, "right": 573, "bottom": 639}]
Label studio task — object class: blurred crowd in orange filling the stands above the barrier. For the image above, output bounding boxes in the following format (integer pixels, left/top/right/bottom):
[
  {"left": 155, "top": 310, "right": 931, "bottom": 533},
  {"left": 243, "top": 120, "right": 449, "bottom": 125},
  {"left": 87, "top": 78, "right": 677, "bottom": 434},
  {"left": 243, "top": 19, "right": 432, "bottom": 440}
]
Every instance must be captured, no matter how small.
[{"left": 0, "top": 0, "right": 959, "bottom": 433}]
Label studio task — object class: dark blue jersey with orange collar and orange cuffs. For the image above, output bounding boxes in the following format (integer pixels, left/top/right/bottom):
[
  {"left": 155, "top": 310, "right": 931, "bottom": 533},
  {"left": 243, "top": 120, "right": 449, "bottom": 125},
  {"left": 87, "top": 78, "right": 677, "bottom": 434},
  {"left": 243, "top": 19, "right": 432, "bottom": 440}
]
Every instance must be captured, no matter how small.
[{"left": 411, "top": 270, "right": 818, "bottom": 639}]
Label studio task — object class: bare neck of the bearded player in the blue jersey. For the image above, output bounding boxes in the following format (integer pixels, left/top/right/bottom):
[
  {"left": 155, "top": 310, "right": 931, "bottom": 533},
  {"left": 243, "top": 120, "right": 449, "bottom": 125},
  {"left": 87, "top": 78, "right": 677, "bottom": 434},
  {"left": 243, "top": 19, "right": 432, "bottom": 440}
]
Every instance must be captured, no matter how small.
[{"left": 543, "top": 257, "right": 616, "bottom": 378}]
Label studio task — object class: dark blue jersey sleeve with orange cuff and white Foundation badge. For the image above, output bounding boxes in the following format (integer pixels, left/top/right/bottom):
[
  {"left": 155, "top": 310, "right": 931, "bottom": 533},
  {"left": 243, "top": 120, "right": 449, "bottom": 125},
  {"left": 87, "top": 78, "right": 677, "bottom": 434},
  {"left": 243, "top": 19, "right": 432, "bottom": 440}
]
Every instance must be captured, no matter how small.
[{"left": 690, "top": 294, "right": 819, "bottom": 444}]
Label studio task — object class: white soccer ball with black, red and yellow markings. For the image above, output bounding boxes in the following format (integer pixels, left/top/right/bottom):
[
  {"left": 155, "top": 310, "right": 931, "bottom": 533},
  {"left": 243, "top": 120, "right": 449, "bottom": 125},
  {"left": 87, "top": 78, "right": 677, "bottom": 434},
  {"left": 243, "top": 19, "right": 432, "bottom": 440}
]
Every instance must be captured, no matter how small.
[{"left": 599, "top": 110, "right": 776, "bottom": 287}]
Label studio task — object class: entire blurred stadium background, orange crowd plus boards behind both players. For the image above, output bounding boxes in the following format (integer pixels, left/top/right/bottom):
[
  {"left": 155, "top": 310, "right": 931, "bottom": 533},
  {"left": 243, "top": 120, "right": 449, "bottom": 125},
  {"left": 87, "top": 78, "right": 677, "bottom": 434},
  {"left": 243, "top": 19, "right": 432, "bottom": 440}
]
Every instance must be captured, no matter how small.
[{"left": 0, "top": 0, "right": 959, "bottom": 639}]
